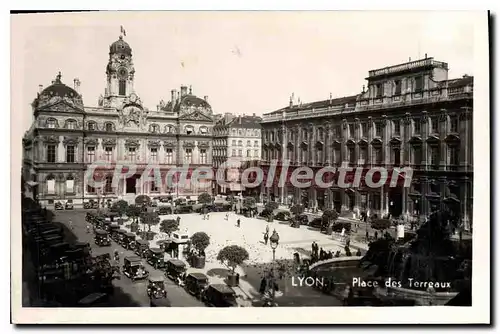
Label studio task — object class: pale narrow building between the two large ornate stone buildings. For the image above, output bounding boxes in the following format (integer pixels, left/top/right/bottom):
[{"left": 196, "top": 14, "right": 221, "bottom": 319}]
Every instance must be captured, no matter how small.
[{"left": 213, "top": 114, "right": 262, "bottom": 195}]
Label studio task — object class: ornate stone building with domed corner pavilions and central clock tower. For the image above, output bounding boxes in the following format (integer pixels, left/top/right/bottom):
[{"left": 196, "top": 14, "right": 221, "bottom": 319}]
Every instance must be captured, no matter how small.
[{"left": 23, "top": 36, "right": 213, "bottom": 205}]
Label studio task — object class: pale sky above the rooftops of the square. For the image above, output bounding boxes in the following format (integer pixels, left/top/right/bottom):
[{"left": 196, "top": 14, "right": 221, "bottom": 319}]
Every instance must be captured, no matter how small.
[{"left": 11, "top": 11, "right": 484, "bottom": 129}]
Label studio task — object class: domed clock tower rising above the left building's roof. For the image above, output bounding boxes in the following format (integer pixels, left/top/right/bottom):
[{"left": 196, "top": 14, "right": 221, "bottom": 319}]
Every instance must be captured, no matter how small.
[{"left": 103, "top": 35, "right": 135, "bottom": 107}]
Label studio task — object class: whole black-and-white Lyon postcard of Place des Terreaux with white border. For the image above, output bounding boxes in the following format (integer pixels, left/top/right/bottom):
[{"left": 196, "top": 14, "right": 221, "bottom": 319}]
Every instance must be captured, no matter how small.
[{"left": 11, "top": 11, "right": 490, "bottom": 324}]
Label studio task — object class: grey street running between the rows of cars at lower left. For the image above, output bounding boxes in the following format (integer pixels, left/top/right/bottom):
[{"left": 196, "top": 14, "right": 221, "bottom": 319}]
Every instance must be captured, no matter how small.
[{"left": 54, "top": 210, "right": 204, "bottom": 307}]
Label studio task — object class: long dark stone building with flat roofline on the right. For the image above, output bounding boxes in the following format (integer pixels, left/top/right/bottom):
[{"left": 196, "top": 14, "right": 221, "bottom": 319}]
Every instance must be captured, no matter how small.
[{"left": 262, "top": 57, "right": 473, "bottom": 228}]
